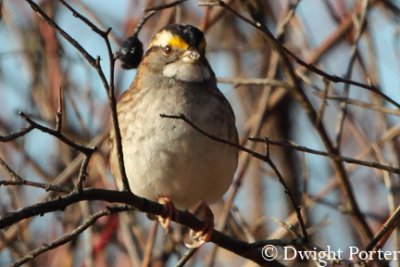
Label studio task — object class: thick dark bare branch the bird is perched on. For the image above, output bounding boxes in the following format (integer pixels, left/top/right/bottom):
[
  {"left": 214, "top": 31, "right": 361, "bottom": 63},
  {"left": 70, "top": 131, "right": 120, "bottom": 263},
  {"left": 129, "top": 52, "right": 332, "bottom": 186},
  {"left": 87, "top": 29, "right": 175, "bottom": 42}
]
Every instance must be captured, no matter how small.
[{"left": 0, "top": 189, "right": 294, "bottom": 266}]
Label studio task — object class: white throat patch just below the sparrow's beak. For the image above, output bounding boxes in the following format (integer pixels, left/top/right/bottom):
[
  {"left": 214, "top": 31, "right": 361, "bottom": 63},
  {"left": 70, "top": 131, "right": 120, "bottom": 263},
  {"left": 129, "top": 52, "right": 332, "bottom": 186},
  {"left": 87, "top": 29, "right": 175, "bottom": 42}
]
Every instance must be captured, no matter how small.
[{"left": 163, "top": 61, "right": 211, "bottom": 82}]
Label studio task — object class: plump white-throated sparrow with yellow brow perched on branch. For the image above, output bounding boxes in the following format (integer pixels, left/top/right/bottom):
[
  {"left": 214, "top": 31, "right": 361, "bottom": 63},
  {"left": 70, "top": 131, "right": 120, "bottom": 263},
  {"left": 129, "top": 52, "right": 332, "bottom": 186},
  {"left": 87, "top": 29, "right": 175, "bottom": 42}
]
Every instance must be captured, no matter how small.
[{"left": 110, "top": 24, "right": 238, "bottom": 247}]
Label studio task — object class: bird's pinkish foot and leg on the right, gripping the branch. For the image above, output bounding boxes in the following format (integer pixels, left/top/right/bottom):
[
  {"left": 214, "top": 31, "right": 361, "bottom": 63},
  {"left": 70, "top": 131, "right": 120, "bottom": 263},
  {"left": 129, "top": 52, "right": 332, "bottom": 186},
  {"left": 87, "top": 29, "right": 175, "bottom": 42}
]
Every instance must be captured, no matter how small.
[{"left": 185, "top": 202, "right": 214, "bottom": 248}]
